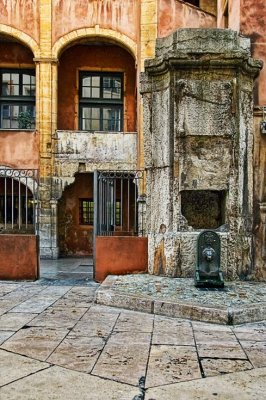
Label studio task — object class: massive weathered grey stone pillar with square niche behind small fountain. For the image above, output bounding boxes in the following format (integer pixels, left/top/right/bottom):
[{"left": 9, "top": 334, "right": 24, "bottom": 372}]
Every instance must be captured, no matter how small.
[{"left": 141, "top": 29, "right": 262, "bottom": 279}]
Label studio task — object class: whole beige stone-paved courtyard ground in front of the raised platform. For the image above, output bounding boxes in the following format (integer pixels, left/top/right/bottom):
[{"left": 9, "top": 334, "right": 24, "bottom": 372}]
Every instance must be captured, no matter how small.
[{"left": 0, "top": 281, "right": 266, "bottom": 400}]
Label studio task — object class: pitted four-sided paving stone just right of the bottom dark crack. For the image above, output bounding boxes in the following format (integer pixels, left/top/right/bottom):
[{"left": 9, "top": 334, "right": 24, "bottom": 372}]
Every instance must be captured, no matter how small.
[{"left": 145, "top": 345, "right": 201, "bottom": 387}]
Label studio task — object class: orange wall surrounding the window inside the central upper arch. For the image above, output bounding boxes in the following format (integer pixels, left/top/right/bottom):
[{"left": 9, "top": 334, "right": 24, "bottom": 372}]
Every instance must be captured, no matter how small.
[{"left": 58, "top": 45, "right": 136, "bottom": 132}]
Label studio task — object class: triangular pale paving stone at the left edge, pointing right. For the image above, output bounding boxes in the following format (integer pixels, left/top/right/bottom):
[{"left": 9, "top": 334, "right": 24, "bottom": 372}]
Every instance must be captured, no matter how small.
[{"left": 0, "top": 350, "right": 49, "bottom": 386}]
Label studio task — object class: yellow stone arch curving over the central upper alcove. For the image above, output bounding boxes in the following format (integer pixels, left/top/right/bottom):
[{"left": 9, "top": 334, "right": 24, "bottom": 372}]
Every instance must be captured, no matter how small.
[{"left": 52, "top": 25, "right": 137, "bottom": 60}]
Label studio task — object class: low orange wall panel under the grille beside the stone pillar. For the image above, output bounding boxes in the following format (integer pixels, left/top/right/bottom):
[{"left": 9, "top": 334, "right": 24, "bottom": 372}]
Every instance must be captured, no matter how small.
[{"left": 95, "top": 236, "right": 148, "bottom": 282}]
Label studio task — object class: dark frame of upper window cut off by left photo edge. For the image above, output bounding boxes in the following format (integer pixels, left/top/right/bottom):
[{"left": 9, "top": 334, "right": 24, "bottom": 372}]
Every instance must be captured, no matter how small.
[{"left": 0, "top": 68, "right": 36, "bottom": 131}]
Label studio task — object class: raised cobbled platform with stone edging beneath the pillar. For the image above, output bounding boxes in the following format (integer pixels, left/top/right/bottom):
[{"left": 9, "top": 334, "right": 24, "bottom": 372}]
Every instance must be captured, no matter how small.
[{"left": 96, "top": 274, "right": 266, "bottom": 325}]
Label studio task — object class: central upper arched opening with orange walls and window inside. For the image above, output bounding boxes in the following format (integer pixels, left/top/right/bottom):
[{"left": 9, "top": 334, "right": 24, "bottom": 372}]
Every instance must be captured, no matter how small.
[{"left": 58, "top": 39, "right": 136, "bottom": 132}]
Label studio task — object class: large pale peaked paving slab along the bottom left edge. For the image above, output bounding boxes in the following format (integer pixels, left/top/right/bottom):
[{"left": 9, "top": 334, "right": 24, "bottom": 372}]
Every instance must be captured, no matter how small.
[{"left": 1, "top": 367, "right": 140, "bottom": 400}]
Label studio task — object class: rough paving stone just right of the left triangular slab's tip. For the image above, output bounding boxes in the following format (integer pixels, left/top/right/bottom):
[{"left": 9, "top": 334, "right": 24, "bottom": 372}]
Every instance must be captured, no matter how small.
[{"left": 47, "top": 335, "right": 105, "bottom": 372}]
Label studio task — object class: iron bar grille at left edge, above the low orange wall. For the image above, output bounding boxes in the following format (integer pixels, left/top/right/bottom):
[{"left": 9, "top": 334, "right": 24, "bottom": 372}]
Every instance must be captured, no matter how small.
[{"left": 0, "top": 168, "right": 38, "bottom": 234}]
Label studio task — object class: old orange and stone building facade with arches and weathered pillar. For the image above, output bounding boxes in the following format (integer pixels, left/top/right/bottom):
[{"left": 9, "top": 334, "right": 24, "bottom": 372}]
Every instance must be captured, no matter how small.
[{"left": 0, "top": 0, "right": 266, "bottom": 280}]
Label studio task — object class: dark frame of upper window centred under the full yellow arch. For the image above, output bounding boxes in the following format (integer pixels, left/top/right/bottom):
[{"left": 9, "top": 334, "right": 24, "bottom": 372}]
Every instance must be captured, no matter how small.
[{"left": 78, "top": 70, "right": 124, "bottom": 132}]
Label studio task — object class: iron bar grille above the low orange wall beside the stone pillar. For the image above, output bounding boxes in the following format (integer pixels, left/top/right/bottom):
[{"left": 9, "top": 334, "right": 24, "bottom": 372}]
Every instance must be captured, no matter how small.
[{"left": 94, "top": 171, "right": 143, "bottom": 236}]
